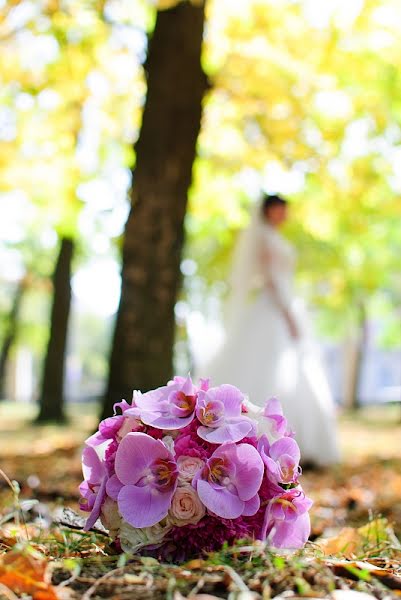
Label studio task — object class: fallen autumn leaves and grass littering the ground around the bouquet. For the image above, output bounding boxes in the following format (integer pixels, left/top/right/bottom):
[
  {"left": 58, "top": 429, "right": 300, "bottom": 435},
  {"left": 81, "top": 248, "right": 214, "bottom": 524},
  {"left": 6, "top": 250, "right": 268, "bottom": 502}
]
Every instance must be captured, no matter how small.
[{"left": 0, "top": 412, "right": 401, "bottom": 600}]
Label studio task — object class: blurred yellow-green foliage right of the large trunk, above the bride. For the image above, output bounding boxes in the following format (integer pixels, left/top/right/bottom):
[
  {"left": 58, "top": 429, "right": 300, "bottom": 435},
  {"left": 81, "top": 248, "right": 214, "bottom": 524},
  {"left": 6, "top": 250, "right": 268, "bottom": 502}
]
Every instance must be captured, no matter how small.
[{"left": 188, "top": 0, "right": 401, "bottom": 344}]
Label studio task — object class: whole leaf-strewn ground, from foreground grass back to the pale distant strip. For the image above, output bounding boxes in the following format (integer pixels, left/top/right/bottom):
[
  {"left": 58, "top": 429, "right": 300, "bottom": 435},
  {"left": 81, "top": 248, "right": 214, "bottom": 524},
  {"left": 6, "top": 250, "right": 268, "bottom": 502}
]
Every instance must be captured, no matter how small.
[{"left": 0, "top": 404, "right": 401, "bottom": 600}]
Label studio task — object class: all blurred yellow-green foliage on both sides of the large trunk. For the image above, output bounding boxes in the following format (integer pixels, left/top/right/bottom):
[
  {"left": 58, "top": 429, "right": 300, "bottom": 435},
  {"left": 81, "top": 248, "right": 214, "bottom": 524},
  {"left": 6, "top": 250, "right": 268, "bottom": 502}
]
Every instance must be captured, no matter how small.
[{"left": 0, "top": 0, "right": 401, "bottom": 372}]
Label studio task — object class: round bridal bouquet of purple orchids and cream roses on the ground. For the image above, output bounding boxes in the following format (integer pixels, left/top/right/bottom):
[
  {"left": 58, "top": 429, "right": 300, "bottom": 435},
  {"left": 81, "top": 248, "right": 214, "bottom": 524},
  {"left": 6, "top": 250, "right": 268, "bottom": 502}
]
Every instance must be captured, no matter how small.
[{"left": 80, "top": 377, "right": 312, "bottom": 560}]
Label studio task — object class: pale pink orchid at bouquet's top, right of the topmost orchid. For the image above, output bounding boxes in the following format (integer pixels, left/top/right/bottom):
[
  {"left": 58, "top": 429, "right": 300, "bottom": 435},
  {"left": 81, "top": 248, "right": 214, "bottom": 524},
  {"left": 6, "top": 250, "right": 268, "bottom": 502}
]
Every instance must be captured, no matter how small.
[{"left": 196, "top": 384, "right": 255, "bottom": 444}]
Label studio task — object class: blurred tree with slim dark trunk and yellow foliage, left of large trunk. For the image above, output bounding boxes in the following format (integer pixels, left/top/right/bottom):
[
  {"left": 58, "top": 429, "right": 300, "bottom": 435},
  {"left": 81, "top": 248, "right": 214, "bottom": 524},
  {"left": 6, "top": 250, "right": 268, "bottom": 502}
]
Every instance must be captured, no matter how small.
[{"left": 0, "top": 0, "right": 138, "bottom": 421}]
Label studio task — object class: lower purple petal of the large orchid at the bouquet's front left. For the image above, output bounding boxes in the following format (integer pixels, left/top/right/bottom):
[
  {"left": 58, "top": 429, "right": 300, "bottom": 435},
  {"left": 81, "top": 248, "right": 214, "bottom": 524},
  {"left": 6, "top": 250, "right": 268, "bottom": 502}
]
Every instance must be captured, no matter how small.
[{"left": 118, "top": 485, "right": 174, "bottom": 528}]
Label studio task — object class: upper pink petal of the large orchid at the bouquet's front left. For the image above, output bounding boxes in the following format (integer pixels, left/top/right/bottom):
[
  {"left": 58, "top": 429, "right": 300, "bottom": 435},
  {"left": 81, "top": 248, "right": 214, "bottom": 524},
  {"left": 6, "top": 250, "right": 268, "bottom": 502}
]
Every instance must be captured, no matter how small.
[{"left": 114, "top": 432, "right": 170, "bottom": 485}]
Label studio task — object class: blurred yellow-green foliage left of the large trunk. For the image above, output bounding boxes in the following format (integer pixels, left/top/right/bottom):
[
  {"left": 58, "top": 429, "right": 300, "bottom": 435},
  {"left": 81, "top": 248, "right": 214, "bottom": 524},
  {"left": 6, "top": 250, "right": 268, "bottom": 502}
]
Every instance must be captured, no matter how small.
[{"left": 0, "top": 0, "right": 144, "bottom": 354}]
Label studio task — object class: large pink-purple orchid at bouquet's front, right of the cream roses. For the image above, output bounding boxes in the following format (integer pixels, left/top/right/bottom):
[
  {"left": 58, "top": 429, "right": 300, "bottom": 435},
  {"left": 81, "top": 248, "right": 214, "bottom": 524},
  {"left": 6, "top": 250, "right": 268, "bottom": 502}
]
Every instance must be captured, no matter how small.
[{"left": 192, "top": 442, "right": 264, "bottom": 519}]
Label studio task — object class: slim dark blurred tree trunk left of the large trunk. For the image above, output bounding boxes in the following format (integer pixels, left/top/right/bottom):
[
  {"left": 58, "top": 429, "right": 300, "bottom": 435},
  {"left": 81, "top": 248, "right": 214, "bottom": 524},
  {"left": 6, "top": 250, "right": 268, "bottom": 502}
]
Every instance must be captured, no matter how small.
[{"left": 37, "top": 237, "right": 74, "bottom": 423}]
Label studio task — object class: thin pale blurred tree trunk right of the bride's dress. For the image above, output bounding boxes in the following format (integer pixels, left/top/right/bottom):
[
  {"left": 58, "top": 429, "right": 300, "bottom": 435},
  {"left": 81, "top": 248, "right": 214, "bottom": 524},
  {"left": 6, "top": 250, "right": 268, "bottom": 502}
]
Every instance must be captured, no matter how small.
[{"left": 345, "top": 301, "right": 368, "bottom": 410}]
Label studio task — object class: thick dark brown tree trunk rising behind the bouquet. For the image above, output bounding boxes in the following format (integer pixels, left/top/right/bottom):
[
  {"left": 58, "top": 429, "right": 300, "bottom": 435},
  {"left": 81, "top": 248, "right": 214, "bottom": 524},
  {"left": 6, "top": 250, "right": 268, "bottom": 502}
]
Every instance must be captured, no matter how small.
[{"left": 103, "top": 2, "right": 206, "bottom": 416}]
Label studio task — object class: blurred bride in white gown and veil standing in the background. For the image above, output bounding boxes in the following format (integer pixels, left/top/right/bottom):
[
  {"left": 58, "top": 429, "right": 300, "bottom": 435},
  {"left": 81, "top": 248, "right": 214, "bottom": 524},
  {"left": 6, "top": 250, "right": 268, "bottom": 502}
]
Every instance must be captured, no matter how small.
[{"left": 198, "top": 196, "right": 338, "bottom": 465}]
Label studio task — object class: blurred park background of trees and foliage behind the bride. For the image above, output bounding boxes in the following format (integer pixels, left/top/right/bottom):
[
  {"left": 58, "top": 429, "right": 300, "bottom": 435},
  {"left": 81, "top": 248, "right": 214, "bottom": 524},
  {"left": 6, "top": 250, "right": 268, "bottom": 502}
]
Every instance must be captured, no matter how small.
[{"left": 0, "top": 0, "right": 401, "bottom": 421}]
